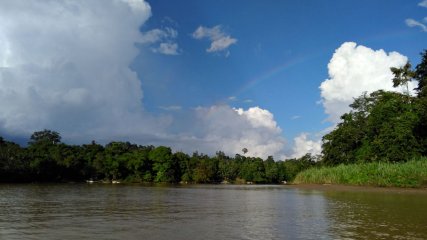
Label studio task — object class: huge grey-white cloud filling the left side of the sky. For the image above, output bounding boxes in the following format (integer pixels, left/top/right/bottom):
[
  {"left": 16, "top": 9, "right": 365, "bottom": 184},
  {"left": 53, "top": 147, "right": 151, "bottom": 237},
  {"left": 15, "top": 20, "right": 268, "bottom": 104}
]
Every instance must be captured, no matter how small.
[{"left": 0, "top": 0, "right": 167, "bottom": 139}]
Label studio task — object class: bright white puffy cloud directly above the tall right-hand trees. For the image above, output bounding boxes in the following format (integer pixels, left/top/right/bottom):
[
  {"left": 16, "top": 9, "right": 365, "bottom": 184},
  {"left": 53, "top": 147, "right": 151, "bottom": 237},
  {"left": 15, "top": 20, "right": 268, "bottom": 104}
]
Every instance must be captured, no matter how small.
[{"left": 320, "top": 42, "right": 415, "bottom": 123}]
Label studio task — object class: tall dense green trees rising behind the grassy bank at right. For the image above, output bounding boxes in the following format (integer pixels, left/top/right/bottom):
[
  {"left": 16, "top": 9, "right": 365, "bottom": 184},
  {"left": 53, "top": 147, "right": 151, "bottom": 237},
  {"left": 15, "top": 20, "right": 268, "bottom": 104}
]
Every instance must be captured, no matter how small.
[{"left": 322, "top": 90, "right": 426, "bottom": 165}]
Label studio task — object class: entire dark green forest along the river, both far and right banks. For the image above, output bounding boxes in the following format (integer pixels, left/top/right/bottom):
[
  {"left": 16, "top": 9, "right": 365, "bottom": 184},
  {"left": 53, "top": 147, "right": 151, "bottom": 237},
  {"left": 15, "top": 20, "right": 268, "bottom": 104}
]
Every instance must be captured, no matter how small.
[{"left": 0, "top": 50, "right": 427, "bottom": 183}]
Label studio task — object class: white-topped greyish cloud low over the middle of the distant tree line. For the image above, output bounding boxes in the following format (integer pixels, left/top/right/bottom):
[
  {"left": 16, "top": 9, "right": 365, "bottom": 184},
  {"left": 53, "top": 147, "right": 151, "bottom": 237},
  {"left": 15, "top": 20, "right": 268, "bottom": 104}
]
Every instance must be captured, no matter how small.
[{"left": 204, "top": 106, "right": 285, "bottom": 158}]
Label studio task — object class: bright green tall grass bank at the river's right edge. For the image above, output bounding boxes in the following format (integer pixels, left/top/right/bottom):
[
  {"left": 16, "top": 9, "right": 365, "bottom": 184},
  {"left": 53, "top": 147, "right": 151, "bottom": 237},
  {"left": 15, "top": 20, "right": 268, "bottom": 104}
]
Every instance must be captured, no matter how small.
[{"left": 294, "top": 157, "right": 427, "bottom": 187}]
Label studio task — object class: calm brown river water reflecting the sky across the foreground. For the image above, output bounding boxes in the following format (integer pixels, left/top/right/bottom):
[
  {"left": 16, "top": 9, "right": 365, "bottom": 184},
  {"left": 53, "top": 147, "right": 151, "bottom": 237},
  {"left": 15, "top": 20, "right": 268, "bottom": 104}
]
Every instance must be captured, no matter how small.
[{"left": 0, "top": 184, "right": 427, "bottom": 240}]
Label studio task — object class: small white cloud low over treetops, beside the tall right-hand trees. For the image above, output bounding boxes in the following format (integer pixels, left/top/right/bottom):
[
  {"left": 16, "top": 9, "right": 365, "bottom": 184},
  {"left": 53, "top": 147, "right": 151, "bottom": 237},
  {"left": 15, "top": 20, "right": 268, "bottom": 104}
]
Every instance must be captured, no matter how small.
[{"left": 292, "top": 133, "right": 322, "bottom": 158}]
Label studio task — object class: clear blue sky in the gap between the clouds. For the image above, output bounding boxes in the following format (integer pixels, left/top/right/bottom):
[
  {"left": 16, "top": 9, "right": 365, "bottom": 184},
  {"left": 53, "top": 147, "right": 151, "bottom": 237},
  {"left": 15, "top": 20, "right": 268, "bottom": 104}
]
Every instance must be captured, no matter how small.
[{"left": 133, "top": 1, "right": 427, "bottom": 152}]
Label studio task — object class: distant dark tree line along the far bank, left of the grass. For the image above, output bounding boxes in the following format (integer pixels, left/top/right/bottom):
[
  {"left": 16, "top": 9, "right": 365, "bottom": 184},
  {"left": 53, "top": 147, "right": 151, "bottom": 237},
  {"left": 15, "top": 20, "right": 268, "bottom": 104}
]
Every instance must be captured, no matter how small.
[{"left": 0, "top": 130, "right": 315, "bottom": 183}]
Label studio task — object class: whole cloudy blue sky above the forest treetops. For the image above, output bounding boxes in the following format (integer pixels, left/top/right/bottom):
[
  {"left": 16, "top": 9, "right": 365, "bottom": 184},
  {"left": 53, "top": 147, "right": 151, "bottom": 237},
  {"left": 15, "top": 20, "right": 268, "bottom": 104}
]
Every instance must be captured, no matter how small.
[{"left": 0, "top": 0, "right": 427, "bottom": 160}]
